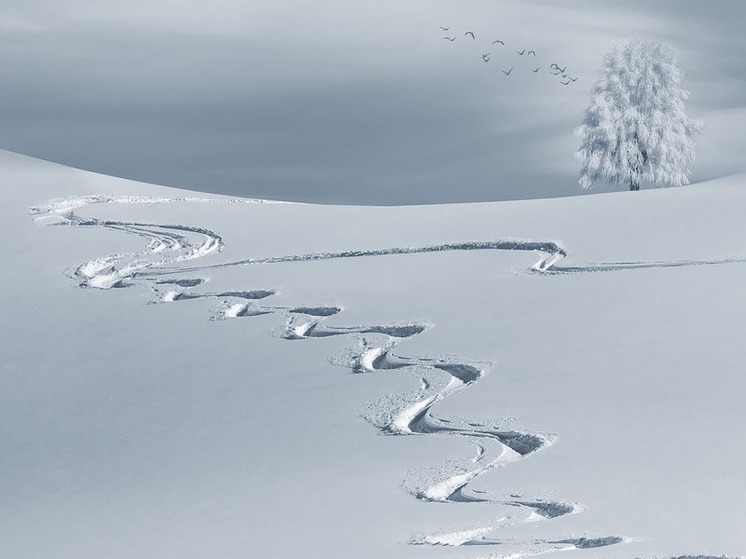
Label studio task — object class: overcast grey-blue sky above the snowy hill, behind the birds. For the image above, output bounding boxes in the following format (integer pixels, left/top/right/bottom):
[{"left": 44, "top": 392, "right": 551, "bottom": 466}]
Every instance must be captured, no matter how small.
[{"left": 0, "top": 0, "right": 746, "bottom": 204}]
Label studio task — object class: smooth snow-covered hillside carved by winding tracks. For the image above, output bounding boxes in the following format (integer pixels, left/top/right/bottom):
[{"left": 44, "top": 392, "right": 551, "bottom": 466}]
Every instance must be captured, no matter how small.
[{"left": 0, "top": 153, "right": 746, "bottom": 559}]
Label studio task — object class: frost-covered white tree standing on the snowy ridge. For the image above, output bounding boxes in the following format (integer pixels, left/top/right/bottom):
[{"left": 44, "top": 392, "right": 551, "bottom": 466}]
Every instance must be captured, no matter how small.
[{"left": 575, "top": 40, "right": 704, "bottom": 190}]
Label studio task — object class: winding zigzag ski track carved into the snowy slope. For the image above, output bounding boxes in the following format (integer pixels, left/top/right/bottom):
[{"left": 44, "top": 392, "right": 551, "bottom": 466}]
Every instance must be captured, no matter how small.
[{"left": 29, "top": 195, "right": 746, "bottom": 559}]
